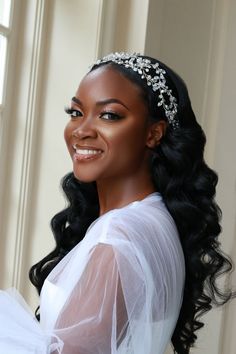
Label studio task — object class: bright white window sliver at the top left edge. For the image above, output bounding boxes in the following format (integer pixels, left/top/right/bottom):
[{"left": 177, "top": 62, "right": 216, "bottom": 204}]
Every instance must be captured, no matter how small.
[{"left": 0, "top": 0, "right": 12, "bottom": 110}]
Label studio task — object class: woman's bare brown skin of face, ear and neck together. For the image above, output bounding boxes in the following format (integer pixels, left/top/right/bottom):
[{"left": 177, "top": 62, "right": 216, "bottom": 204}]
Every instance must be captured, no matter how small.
[{"left": 64, "top": 66, "right": 166, "bottom": 215}]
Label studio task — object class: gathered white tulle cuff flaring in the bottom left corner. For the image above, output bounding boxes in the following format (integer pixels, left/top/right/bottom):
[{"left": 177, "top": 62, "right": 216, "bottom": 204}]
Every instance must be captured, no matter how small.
[{"left": 0, "top": 288, "right": 64, "bottom": 354}]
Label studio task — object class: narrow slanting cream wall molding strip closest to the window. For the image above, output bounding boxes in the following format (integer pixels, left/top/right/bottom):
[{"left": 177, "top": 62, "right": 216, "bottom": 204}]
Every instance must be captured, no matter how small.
[{"left": 12, "top": 0, "right": 46, "bottom": 289}]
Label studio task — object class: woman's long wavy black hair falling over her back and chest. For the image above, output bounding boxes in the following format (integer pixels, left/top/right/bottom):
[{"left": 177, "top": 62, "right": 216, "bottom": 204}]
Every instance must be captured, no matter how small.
[{"left": 30, "top": 57, "right": 235, "bottom": 354}]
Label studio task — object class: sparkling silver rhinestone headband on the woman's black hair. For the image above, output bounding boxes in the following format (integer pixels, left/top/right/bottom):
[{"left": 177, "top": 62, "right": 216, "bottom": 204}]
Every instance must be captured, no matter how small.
[{"left": 95, "top": 52, "right": 179, "bottom": 129}]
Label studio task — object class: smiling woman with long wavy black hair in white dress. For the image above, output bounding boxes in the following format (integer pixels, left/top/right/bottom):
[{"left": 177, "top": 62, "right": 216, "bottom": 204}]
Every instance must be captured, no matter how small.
[{"left": 0, "top": 53, "right": 234, "bottom": 354}]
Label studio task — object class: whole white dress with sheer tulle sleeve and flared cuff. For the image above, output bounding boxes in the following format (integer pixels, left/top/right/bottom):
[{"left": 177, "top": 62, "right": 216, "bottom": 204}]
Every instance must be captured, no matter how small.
[{"left": 0, "top": 193, "right": 185, "bottom": 354}]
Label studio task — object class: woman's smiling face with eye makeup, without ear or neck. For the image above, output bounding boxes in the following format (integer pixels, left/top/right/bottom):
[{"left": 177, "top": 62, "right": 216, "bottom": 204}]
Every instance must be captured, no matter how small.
[{"left": 65, "top": 66, "right": 154, "bottom": 182}]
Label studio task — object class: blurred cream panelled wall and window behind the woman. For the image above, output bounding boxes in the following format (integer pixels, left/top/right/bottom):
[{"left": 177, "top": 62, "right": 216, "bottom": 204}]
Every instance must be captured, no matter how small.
[{"left": 0, "top": 0, "right": 236, "bottom": 354}]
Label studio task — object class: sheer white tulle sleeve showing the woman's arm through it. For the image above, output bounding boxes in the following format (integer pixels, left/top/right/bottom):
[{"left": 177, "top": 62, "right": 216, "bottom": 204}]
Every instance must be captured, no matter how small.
[{"left": 55, "top": 243, "right": 128, "bottom": 354}]
